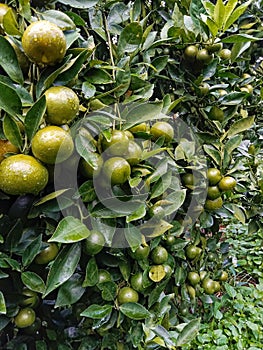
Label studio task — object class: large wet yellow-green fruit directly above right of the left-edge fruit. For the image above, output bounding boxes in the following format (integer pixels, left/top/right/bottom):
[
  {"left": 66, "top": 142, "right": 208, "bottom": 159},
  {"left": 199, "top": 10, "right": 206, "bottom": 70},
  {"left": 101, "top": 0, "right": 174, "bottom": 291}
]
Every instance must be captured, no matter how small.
[{"left": 32, "top": 125, "right": 74, "bottom": 164}]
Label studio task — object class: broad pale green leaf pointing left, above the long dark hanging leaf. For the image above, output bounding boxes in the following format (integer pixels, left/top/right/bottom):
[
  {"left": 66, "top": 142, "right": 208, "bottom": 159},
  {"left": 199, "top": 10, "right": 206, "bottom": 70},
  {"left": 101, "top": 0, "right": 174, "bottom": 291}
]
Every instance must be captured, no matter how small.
[{"left": 48, "top": 216, "right": 90, "bottom": 243}]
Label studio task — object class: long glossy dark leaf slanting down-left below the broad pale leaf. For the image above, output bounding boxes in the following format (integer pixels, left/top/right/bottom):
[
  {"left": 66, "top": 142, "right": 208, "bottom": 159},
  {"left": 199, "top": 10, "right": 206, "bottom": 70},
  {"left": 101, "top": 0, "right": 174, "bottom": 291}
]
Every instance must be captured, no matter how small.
[{"left": 44, "top": 243, "right": 81, "bottom": 297}]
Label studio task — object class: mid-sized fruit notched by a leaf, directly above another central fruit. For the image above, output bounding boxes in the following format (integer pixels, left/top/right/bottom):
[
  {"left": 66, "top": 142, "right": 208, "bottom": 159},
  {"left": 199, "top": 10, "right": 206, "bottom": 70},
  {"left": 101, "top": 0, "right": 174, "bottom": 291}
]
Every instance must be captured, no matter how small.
[{"left": 101, "top": 129, "right": 130, "bottom": 156}]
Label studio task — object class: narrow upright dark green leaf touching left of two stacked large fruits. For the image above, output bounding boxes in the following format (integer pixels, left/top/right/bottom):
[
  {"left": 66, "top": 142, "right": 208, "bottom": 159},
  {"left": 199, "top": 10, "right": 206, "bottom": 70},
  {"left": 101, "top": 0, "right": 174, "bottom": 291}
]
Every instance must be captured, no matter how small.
[{"left": 25, "top": 95, "right": 46, "bottom": 141}]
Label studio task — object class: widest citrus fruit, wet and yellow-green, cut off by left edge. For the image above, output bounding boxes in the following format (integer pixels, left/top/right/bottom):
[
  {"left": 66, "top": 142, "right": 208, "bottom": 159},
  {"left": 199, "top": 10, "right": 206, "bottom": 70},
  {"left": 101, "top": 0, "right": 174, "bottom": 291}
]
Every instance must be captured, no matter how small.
[{"left": 0, "top": 154, "right": 48, "bottom": 195}]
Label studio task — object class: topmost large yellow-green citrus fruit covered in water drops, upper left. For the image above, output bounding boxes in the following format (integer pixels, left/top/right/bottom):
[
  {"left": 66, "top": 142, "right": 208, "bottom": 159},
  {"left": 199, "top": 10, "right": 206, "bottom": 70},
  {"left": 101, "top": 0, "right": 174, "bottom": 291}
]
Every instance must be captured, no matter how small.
[{"left": 22, "top": 20, "right": 66, "bottom": 65}]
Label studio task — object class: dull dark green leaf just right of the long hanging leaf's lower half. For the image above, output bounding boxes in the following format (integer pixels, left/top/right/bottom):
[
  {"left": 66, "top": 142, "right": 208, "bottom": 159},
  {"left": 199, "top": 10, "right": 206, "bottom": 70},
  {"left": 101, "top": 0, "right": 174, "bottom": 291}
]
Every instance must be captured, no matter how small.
[{"left": 55, "top": 273, "right": 86, "bottom": 308}]
